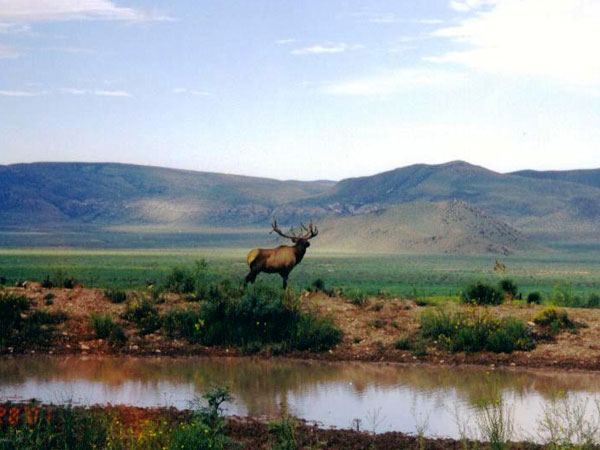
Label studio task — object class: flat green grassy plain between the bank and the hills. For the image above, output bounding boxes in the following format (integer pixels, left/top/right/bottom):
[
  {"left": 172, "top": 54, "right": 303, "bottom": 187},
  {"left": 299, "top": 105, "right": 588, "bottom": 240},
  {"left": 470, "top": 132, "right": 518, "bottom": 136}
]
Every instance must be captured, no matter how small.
[{"left": 0, "top": 244, "right": 600, "bottom": 299}]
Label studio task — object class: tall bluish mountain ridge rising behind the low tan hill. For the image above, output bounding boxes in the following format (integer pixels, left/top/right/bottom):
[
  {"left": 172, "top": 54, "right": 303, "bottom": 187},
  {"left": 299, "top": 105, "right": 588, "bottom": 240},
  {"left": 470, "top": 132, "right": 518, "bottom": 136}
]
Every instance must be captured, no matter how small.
[{"left": 290, "top": 161, "right": 600, "bottom": 239}]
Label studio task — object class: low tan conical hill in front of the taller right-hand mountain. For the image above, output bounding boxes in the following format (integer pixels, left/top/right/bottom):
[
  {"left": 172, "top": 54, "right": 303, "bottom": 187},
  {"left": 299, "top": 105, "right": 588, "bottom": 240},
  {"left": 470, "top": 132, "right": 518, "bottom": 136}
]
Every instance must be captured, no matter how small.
[{"left": 319, "top": 200, "right": 536, "bottom": 254}]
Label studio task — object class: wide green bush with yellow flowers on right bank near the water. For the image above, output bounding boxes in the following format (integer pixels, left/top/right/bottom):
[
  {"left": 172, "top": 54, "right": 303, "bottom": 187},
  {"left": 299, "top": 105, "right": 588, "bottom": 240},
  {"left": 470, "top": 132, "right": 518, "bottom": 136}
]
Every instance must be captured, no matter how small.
[{"left": 420, "top": 310, "right": 535, "bottom": 353}]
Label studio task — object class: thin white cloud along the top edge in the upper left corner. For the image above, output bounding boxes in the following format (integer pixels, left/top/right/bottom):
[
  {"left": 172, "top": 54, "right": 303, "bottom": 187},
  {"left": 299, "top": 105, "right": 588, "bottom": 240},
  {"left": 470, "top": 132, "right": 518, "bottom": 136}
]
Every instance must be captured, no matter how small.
[{"left": 0, "top": 0, "right": 167, "bottom": 23}]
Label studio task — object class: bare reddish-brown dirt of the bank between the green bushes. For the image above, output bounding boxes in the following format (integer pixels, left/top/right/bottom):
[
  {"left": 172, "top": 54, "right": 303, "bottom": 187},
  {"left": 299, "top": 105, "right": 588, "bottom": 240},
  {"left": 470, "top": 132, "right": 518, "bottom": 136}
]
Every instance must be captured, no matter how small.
[{"left": 5, "top": 283, "right": 600, "bottom": 370}]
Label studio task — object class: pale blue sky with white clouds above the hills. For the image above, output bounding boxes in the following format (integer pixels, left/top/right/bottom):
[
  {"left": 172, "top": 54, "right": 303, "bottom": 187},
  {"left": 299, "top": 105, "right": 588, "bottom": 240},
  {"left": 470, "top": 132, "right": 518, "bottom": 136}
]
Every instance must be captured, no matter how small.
[{"left": 0, "top": 0, "right": 600, "bottom": 180}]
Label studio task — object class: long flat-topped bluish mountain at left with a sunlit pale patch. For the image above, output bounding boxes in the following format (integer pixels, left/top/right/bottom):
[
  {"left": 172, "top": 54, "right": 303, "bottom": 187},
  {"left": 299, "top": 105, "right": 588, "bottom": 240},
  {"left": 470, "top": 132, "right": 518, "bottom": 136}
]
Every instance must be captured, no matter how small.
[{"left": 0, "top": 163, "right": 334, "bottom": 225}]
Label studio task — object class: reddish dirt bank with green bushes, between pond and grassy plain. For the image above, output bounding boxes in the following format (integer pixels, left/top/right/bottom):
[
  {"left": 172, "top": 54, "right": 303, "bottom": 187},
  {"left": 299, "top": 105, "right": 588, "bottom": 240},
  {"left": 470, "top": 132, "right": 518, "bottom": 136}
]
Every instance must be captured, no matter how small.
[{"left": 0, "top": 262, "right": 600, "bottom": 370}]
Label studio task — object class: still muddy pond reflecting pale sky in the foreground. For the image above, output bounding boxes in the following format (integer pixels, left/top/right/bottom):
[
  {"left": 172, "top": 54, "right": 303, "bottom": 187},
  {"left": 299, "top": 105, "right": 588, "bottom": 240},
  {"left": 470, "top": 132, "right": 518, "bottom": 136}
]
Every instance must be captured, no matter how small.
[{"left": 0, "top": 356, "right": 600, "bottom": 439}]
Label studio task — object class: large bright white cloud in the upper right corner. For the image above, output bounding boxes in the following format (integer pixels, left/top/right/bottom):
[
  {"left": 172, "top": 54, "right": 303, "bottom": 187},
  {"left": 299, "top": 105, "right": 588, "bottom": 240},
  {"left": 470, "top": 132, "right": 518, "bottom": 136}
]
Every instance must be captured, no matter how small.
[{"left": 427, "top": 0, "right": 600, "bottom": 85}]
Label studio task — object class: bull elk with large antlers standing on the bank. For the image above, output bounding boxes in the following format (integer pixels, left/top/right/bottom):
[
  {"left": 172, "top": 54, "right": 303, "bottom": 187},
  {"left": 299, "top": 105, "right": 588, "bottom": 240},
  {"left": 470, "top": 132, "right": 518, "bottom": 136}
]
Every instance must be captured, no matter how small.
[{"left": 245, "top": 220, "right": 319, "bottom": 289}]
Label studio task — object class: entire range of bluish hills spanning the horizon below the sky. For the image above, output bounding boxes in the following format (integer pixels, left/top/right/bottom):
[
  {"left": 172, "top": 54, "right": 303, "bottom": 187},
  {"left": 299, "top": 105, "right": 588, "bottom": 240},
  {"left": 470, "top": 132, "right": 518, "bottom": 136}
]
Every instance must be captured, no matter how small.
[{"left": 0, "top": 161, "right": 600, "bottom": 253}]
